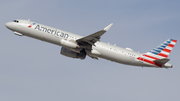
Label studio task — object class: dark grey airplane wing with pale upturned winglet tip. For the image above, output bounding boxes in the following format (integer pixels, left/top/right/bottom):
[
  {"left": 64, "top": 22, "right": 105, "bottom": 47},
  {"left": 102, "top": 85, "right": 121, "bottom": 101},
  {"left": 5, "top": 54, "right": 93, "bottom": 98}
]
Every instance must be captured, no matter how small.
[{"left": 76, "top": 23, "right": 113, "bottom": 45}]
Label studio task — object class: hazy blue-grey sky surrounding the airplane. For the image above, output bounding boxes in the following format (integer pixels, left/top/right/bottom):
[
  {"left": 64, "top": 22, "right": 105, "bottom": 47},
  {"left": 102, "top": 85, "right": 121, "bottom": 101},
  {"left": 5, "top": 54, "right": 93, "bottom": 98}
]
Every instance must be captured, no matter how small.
[{"left": 0, "top": 0, "right": 180, "bottom": 101}]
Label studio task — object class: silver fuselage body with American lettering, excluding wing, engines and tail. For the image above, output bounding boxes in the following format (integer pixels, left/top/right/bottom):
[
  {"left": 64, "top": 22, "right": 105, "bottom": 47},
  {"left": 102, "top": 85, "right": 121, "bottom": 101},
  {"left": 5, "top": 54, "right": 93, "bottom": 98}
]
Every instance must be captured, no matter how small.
[{"left": 6, "top": 20, "right": 172, "bottom": 67}]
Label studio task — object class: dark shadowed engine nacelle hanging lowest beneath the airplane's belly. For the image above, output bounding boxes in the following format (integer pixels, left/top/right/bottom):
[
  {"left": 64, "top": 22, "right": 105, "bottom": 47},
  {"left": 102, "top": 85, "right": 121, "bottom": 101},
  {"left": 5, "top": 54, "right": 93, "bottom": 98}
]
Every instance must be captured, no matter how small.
[{"left": 61, "top": 47, "right": 86, "bottom": 60}]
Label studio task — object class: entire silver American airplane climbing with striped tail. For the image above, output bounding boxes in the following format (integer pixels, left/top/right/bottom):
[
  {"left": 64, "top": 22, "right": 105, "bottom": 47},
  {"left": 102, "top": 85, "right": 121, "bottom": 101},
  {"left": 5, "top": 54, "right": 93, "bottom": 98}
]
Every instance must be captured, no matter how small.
[{"left": 5, "top": 19, "right": 177, "bottom": 68}]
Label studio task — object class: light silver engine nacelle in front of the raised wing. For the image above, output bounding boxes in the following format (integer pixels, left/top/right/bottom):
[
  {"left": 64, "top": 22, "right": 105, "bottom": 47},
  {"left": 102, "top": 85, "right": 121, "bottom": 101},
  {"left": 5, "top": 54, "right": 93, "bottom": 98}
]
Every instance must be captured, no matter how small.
[{"left": 60, "top": 39, "right": 79, "bottom": 48}]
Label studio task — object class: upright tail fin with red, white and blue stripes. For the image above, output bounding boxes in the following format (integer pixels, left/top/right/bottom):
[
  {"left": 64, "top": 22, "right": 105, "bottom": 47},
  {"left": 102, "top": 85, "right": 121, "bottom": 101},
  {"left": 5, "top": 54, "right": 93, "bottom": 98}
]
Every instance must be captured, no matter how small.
[{"left": 143, "top": 39, "right": 177, "bottom": 60}]
